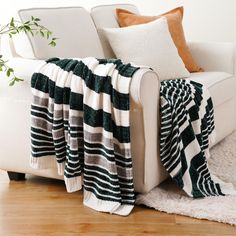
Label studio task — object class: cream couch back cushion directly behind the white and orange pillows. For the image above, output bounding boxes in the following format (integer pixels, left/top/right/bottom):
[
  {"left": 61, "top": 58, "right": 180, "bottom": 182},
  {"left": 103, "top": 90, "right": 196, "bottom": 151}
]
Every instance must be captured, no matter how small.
[{"left": 91, "top": 4, "right": 139, "bottom": 58}]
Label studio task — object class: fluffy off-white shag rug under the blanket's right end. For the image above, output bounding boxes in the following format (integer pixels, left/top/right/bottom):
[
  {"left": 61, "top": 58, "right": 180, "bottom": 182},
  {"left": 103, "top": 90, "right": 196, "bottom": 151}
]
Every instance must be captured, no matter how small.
[{"left": 136, "top": 132, "right": 236, "bottom": 225}]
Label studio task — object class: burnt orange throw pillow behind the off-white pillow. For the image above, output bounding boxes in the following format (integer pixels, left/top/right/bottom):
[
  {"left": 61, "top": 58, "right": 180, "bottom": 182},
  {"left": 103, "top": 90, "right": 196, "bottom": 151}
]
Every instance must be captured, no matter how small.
[{"left": 116, "top": 7, "right": 203, "bottom": 72}]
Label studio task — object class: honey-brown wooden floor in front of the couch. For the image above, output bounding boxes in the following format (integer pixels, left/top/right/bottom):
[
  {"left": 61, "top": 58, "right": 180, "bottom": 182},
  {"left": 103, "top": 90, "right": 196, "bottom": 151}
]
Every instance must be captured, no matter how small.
[{"left": 0, "top": 170, "right": 236, "bottom": 236}]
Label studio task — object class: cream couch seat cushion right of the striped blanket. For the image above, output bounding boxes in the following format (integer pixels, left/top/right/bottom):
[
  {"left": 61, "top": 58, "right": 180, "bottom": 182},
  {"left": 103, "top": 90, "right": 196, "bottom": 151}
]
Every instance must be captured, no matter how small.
[{"left": 190, "top": 72, "right": 236, "bottom": 107}]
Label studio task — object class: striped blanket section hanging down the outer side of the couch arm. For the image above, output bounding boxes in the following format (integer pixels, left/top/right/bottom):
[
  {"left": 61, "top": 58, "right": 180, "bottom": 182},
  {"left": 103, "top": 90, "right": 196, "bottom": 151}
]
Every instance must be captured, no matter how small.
[{"left": 31, "top": 58, "right": 138, "bottom": 215}]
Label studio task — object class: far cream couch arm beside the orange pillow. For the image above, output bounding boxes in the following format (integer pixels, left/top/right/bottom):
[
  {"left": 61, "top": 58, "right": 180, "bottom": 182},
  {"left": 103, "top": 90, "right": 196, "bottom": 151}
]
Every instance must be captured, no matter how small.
[{"left": 188, "top": 42, "right": 236, "bottom": 75}]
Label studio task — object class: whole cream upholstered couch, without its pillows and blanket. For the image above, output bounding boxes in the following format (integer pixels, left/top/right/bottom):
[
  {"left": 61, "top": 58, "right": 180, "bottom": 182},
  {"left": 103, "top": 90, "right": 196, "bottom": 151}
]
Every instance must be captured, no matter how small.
[{"left": 0, "top": 4, "right": 236, "bottom": 192}]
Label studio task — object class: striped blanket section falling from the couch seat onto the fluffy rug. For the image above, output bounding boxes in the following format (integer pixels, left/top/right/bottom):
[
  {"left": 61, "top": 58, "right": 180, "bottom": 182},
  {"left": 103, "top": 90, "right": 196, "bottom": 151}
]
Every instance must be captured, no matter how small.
[{"left": 160, "top": 79, "right": 235, "bottom": 198}]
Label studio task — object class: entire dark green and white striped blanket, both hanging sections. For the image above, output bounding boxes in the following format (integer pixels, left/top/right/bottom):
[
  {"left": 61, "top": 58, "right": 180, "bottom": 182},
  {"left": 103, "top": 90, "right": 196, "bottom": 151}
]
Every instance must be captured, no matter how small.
[{"left": 31, "top": 58, "right": 232, "bottom": 215}]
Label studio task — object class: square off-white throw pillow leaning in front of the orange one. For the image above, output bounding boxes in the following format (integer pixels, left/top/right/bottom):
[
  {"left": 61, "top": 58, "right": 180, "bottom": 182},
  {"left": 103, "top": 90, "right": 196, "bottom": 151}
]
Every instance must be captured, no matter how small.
[{"left": 104, "top": 17, "right": 190, "bottom": 80}]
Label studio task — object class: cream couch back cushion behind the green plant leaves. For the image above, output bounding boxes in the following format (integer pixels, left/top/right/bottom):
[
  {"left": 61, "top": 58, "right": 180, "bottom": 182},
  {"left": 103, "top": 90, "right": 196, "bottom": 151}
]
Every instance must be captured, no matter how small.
[{"left": 15, "top": 7, "right": 104, "bottom": 59}]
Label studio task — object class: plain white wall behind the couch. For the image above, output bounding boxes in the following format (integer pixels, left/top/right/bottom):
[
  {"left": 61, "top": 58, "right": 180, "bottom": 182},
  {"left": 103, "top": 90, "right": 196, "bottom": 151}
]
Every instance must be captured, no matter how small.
[{"left": 0, "top": 0, "right": 236, "bottom": 42}]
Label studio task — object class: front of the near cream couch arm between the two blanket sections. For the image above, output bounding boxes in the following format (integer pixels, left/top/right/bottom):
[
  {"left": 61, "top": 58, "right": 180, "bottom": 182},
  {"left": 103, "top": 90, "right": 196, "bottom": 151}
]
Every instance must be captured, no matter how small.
[{"left": 130, "top": 69, "right": 167, "bottom": 192}]
